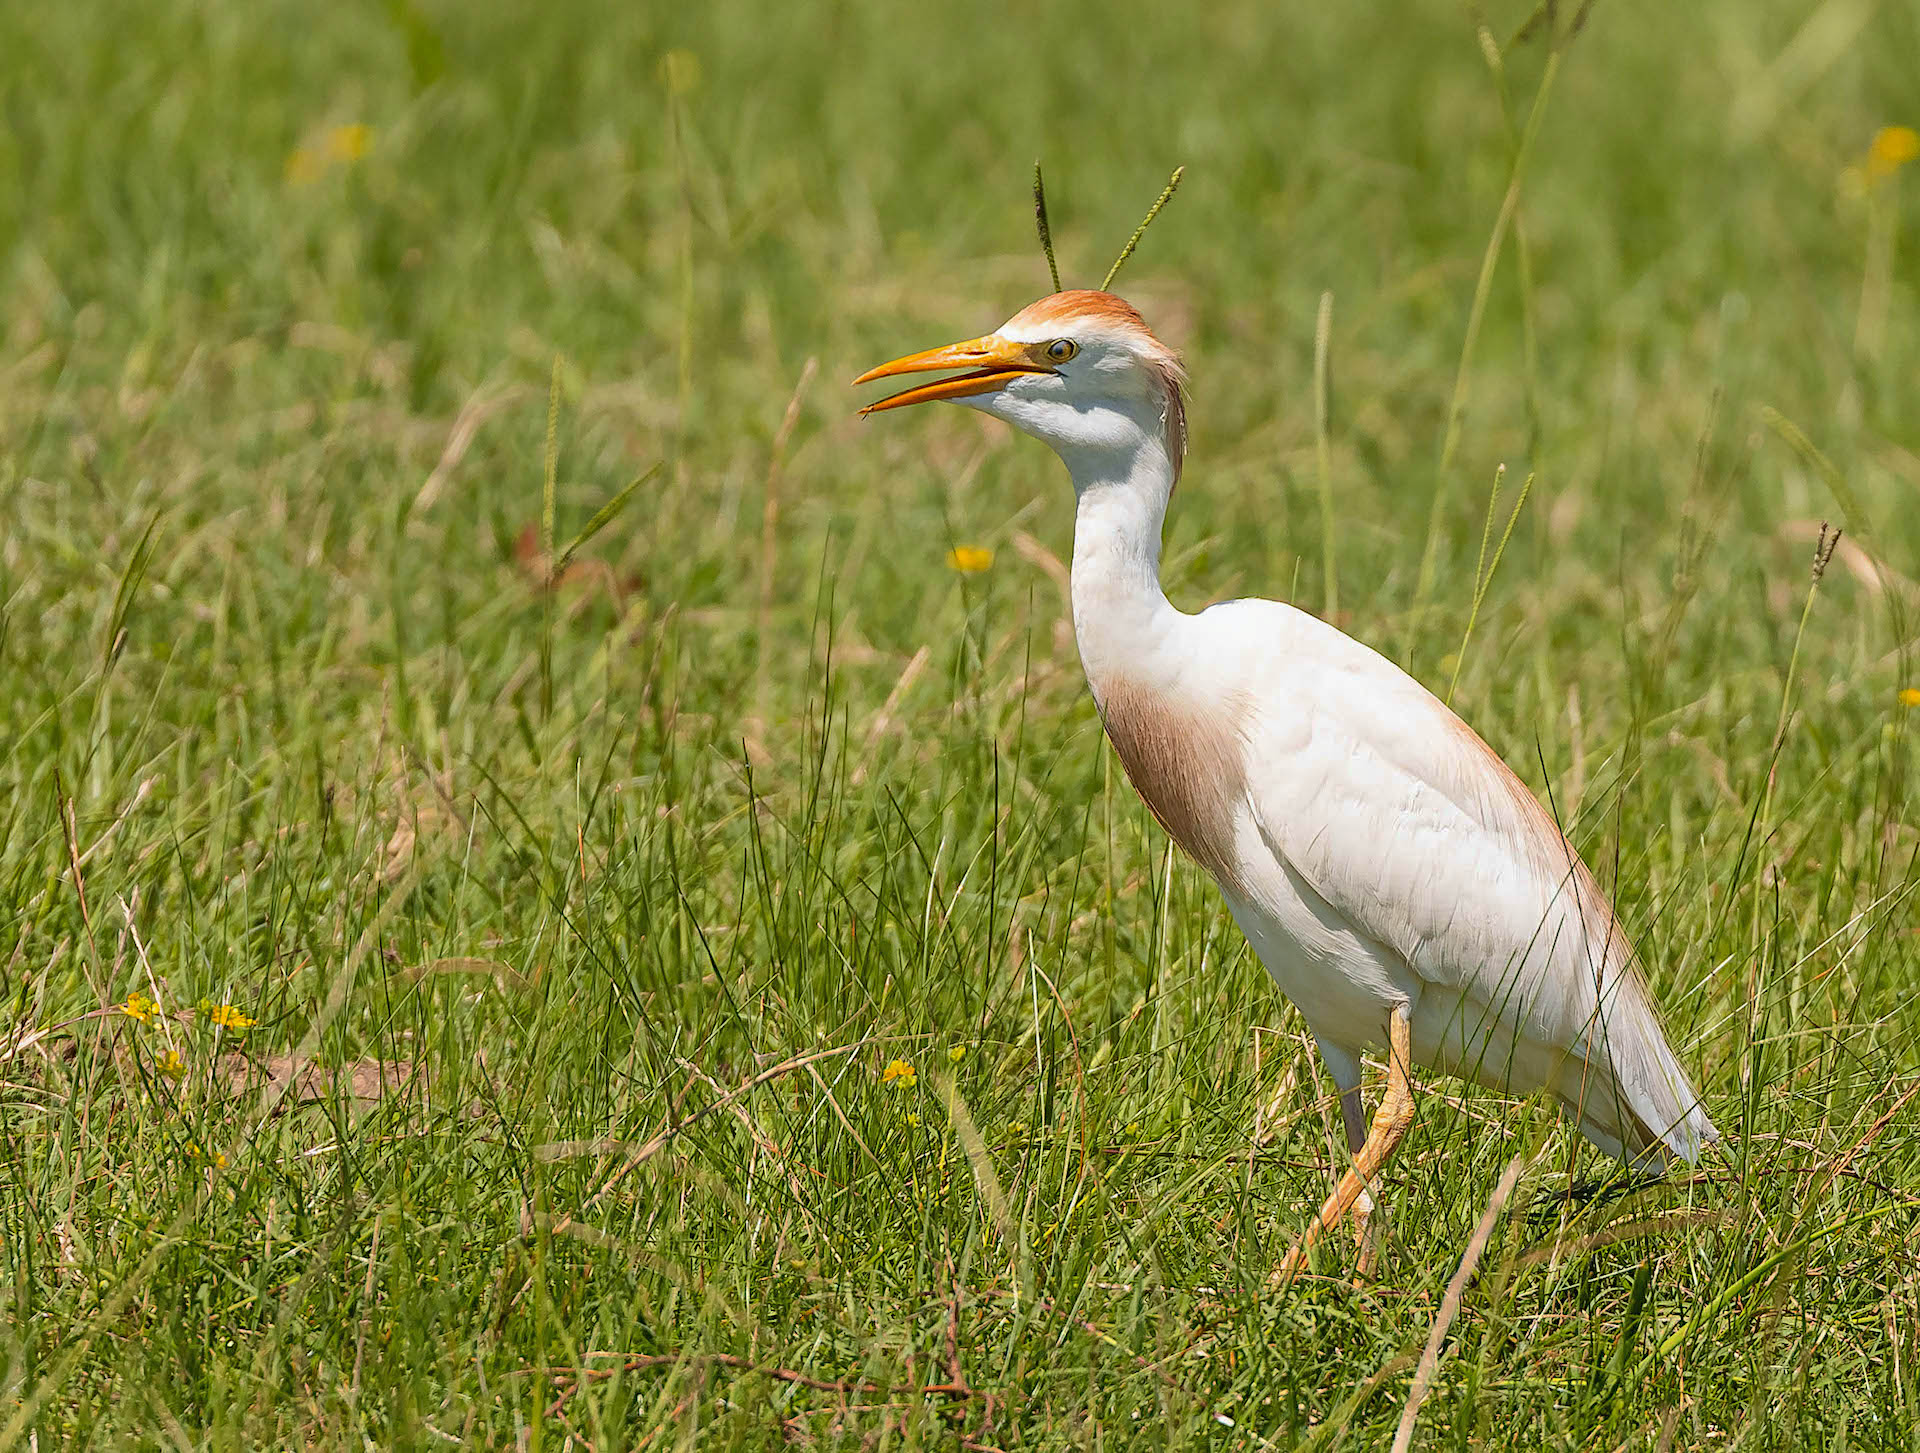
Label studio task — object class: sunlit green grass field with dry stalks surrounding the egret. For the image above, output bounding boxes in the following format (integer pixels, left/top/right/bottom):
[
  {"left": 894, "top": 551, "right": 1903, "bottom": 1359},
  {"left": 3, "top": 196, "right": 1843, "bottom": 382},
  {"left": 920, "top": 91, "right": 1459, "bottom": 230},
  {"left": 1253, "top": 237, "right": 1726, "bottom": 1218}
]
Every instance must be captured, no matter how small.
[{"left": 0, "top": 0, "right": 1920, "bottom": 1449}]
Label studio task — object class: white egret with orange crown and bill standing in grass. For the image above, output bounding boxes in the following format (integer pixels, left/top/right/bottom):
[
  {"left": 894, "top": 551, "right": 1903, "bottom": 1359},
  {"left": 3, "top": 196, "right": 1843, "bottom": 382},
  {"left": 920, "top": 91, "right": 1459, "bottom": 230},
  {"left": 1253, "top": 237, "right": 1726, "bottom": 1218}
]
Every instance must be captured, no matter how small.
[{"left": 854, "top": 290, "right": 1718, "bottom": 1278}]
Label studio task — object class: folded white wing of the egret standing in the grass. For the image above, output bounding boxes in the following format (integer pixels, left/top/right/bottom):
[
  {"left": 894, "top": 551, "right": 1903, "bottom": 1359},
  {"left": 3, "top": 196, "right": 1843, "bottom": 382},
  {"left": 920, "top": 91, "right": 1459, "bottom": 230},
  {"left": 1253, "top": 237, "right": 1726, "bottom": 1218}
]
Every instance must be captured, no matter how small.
[{"left": 1213, "top": 610, "right": 1711, "bottom": 1154}]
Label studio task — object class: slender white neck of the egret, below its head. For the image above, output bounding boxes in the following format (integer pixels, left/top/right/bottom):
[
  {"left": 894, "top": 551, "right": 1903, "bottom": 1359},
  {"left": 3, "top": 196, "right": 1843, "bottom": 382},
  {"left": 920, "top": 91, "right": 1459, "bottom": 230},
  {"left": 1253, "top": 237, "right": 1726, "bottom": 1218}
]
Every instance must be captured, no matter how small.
[{"left": 1060, "top": 408, "right": 1185, "bottom": 703}]
